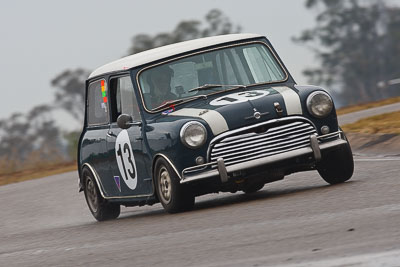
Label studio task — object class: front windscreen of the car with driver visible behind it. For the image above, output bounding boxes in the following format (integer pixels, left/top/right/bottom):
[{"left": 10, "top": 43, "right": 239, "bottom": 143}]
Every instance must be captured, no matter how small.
[{"left": 139, "top": 43, "right": 286, "bottom": 110}]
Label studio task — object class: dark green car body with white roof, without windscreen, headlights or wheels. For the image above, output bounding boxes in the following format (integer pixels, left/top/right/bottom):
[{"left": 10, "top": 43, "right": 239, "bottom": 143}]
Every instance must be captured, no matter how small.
[{"left": 78, "top": 35, "right": 354, "bottom": 218}]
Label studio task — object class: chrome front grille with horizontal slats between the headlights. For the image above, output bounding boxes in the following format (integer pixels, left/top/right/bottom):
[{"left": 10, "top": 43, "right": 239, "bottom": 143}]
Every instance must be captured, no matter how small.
[{"left": 210, "top": 121, "right": 317, "bottom": 166}]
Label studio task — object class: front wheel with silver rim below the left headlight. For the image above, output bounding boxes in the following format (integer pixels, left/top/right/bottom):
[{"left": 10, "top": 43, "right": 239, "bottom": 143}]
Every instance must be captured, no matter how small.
[{"left": 154, "top": 158, "right": 194, "bottom": 213}]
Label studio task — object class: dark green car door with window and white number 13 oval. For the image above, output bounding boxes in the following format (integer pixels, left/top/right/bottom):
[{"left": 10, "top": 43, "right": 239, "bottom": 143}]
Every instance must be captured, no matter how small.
[{"left": 107, "top": 74, "right": 153, "bottom": 197}]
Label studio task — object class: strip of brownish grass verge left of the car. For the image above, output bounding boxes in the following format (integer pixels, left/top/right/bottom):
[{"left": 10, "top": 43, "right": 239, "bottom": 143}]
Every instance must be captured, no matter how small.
[{"left": 0, "top": 162, "right": 77, "bottom": 185}]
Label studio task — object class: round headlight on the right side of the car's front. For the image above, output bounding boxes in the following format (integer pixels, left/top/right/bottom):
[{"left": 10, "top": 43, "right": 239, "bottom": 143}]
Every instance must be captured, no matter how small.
[{"left": 307, "top": 91, "right": 333, "bottom": 118}]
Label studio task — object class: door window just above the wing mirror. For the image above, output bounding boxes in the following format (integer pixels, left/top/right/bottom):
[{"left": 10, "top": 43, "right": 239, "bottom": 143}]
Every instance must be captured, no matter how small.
[{"left": 110, "top": 76, "right": 141, "bottom": 122}]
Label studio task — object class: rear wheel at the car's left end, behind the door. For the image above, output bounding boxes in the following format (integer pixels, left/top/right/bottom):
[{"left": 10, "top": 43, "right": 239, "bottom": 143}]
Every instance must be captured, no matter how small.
[{"left": 82, "top": 168, "right": 121, "bottom": 221}]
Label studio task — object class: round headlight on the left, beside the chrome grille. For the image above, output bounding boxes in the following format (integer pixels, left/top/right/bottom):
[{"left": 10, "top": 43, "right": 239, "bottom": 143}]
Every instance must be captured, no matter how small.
[{"left": 180, "top": 121, "right": 207, "bottom": 148}]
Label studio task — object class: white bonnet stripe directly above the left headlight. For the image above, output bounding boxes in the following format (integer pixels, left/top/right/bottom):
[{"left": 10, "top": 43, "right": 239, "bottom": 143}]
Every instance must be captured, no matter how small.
[{"left": 168, "top": 108, "right": 229, "bottom": 135}]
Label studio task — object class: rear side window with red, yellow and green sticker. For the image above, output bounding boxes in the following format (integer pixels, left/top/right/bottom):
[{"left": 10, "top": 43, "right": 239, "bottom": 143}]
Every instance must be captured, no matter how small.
[{"left": 87, "top": 80, "right": 109, "bottom": 125}]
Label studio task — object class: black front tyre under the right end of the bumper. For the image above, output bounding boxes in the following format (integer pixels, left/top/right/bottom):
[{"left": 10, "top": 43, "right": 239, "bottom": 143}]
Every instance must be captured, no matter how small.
[{"left": 317, "top": 135, "right": 354, "bottom": 184}]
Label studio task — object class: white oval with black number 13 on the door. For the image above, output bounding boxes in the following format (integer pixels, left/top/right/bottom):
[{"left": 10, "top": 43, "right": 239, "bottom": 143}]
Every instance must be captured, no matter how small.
[{"left": 115, "top": 130, "right": 137, "bottom": 190}]
